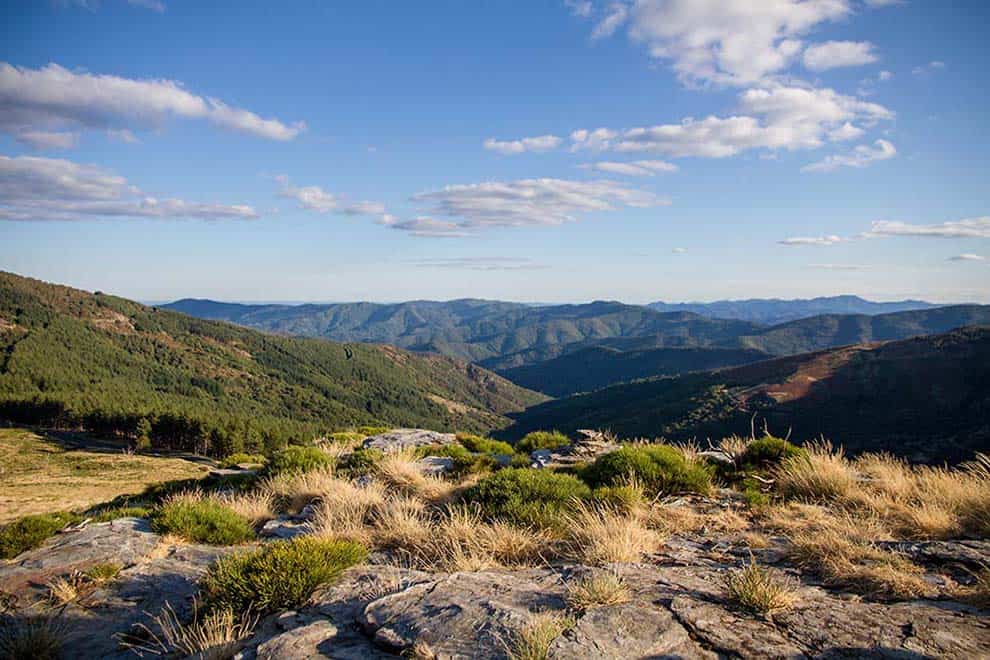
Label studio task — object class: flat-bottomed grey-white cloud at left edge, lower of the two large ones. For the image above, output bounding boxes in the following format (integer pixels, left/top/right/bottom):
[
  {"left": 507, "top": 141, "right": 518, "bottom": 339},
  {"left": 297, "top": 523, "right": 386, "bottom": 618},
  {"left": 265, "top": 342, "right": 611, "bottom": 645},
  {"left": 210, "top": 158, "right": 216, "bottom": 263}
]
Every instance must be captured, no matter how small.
[{"left": 0, "top": 156, "right": 258, "bottom": 221}]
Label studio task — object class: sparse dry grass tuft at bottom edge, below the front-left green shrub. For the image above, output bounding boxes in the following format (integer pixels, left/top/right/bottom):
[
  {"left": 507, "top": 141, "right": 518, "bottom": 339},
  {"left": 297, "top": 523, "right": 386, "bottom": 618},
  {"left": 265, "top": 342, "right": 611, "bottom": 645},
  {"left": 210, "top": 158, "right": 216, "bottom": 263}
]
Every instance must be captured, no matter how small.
[{"left": 121, "top": 602, "right": 258, "bottom": 660}]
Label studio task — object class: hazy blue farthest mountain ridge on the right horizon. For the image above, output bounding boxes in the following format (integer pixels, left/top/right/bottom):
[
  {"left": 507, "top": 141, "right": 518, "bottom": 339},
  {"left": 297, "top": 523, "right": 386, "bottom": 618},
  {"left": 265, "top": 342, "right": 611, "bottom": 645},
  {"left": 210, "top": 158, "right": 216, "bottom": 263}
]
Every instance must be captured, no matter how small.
[{"left": 647, "top": 295, "right": 944, "bottom": 325}]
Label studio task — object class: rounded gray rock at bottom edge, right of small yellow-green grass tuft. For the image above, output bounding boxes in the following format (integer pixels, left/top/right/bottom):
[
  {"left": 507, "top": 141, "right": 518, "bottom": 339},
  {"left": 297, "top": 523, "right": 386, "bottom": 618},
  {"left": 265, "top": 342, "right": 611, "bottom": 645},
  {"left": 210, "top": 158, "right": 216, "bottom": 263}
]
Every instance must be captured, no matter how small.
[{"left": 547, "top": 601, "right": 716, "bottom": 660}]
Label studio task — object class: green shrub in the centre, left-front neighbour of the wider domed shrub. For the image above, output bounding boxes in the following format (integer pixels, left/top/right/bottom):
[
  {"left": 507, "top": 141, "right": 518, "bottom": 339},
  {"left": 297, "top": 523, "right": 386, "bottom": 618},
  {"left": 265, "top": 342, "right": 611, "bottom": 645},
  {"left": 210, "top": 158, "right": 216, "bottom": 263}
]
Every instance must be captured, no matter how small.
[{"left": 464, "top": 468, "right": 591, "bottom": 528}]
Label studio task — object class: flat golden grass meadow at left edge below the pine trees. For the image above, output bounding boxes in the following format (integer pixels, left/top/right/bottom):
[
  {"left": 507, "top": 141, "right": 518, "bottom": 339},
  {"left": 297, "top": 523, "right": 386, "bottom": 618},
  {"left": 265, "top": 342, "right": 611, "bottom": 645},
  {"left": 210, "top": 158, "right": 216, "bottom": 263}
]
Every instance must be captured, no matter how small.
[{"left": 0, "top": 429, "right": 205, "bottom": 524}]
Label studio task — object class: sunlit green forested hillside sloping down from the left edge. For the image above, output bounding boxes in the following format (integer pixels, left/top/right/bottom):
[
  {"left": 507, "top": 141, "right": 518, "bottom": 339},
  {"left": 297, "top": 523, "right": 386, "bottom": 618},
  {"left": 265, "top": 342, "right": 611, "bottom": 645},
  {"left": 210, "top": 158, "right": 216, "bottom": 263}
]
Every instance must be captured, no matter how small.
[{"left": 0, "top": 273, "right": 543, "bottom": 454}]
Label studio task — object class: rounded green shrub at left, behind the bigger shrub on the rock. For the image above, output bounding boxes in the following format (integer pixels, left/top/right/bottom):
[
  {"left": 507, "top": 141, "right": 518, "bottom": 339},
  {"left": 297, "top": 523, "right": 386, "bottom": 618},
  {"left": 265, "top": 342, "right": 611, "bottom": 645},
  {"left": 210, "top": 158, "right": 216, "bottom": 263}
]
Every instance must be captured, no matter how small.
[{"left": 151, "top": 496, "right": 254, "bottom": 545}]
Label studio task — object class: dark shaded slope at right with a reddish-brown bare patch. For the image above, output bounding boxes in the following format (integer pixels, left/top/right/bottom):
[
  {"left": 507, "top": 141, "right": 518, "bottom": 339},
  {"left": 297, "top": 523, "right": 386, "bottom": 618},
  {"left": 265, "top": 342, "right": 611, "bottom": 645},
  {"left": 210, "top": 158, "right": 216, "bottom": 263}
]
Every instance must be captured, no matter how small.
[{"left": 502, "top": 327, "right": 990, "bottom": 462}]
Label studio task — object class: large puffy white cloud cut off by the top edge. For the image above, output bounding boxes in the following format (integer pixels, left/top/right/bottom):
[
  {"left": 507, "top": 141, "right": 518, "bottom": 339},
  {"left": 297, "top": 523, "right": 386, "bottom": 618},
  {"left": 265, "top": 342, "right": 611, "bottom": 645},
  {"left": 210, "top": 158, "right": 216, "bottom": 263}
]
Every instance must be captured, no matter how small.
[{"left": 628, "top": 0, "right": 852, "bottom": 85}]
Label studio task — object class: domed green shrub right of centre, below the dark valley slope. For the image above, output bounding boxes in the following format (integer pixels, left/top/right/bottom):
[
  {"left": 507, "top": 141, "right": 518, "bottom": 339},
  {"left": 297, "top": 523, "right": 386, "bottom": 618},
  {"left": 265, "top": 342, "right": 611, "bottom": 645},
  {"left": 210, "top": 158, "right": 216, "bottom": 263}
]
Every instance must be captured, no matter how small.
[{"left": 582, "top": 445, "right": 712, "bottom": 496}]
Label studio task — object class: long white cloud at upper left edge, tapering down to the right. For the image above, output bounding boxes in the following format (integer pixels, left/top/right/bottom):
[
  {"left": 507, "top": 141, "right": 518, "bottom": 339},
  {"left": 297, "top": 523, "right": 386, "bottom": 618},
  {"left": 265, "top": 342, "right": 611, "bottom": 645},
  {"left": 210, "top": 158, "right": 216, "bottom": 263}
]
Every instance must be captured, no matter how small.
[{"left": 0, "top": 62, "right": 305, "bottom": 148}]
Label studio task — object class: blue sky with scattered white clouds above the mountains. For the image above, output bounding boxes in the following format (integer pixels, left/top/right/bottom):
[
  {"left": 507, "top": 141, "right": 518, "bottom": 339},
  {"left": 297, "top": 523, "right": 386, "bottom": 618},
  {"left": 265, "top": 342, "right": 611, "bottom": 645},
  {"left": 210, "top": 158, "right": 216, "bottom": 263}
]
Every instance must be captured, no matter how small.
[{"left": 0, "top": 0, "right": 990, "bottom": 303}]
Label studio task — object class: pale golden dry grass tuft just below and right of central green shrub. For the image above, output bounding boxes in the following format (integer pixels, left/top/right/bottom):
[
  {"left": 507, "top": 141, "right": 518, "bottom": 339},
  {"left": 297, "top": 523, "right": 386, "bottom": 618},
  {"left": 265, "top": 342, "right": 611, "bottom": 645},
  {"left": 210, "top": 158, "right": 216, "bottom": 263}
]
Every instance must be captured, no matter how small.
[{"left": 565, "top": 503, "right": 660, "bottom": 566}]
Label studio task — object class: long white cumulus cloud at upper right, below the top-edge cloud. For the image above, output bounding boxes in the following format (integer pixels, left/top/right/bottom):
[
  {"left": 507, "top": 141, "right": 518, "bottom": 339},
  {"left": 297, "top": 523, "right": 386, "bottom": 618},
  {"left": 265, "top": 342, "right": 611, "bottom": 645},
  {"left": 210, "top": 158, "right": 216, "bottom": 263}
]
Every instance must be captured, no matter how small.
[{"left": 571, "top": 86, "right": 894, "bottom": 158}]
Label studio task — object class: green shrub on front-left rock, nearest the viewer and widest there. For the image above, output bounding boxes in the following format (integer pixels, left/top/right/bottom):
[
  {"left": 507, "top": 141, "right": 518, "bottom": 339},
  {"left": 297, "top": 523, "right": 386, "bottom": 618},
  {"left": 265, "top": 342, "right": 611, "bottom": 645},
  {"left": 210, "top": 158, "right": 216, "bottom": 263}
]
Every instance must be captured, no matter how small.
[{"left": 202, "top": 536, "right": 367, "bottom": 615}]
